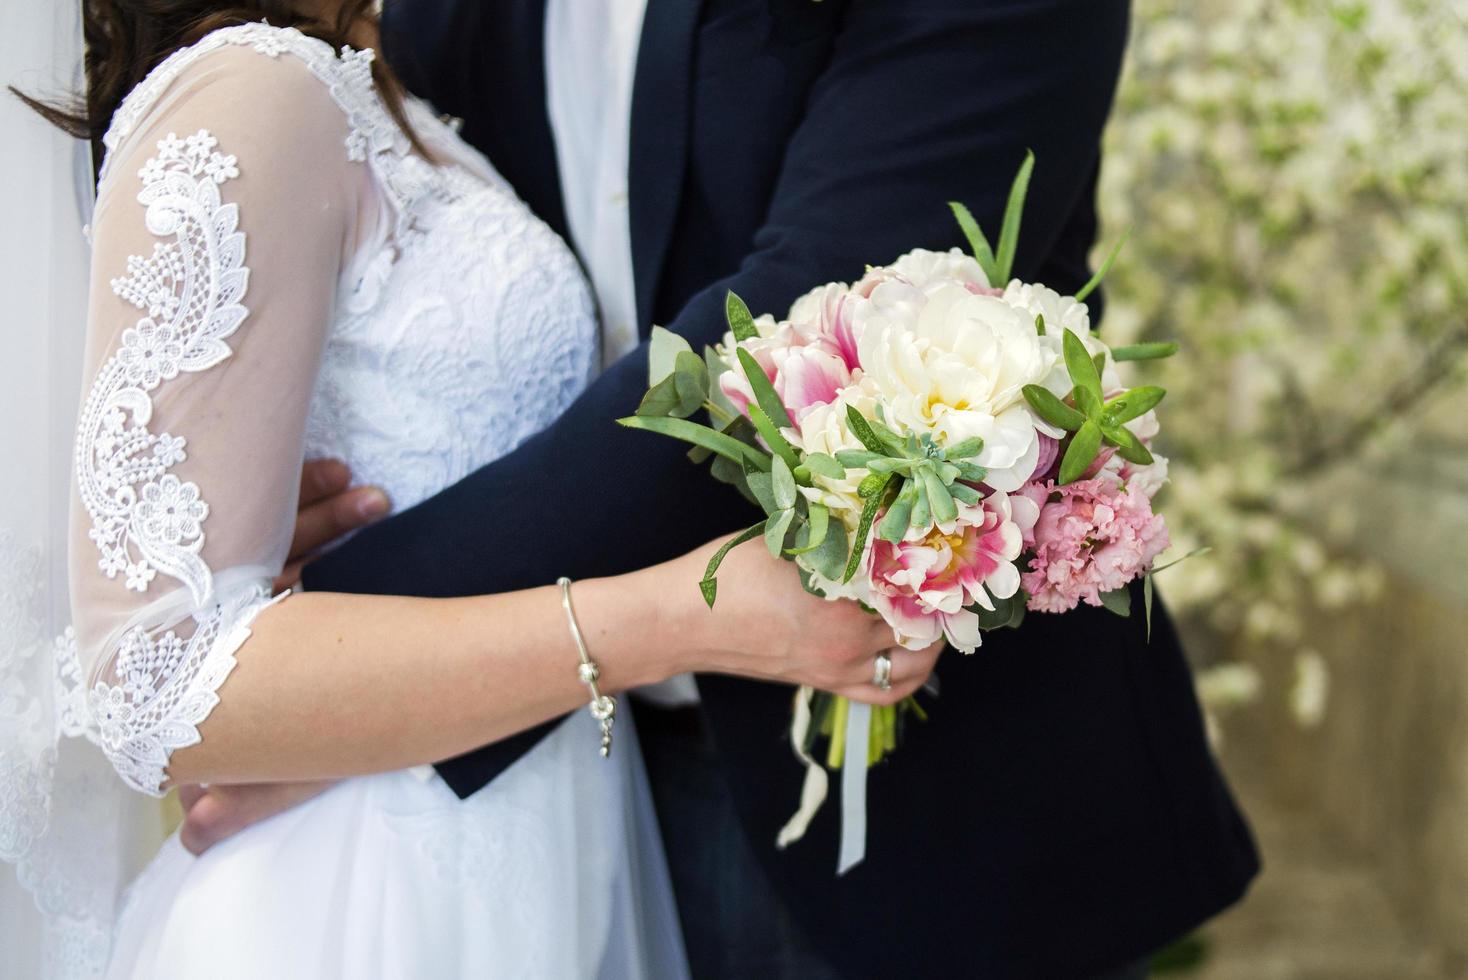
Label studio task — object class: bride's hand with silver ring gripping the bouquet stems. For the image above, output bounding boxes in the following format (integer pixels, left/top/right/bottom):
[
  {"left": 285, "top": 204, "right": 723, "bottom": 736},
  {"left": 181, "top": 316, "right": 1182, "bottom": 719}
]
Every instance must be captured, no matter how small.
[{"left": 661, "top": 540, "right": 944, "bottom": 704}]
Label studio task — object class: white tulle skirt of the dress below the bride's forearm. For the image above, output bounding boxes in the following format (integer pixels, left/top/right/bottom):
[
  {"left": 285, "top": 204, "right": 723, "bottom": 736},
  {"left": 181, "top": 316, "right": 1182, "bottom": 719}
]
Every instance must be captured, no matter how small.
[{"left": 107, "top": 712, "right": 687, "bottom": 980}]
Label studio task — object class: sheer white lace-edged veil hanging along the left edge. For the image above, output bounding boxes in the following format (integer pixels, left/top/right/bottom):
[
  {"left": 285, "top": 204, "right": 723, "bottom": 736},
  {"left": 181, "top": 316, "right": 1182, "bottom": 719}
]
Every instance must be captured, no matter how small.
[{"left": 0, "top": 7, "right": 163, "bottom": 979}]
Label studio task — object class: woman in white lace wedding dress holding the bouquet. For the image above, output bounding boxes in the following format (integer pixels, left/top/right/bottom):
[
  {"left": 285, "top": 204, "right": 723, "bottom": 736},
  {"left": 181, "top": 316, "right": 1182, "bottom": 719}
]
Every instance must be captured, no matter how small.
[{"left": 0, "top": 0, "right": 937, "bottom": 979}]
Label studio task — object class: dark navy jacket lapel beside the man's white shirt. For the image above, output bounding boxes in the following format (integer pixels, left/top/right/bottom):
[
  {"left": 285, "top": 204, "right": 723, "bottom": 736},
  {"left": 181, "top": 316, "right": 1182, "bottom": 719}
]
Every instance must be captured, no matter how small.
[{"left": 628, "top": 0, "right": 703, "bottom": 332}]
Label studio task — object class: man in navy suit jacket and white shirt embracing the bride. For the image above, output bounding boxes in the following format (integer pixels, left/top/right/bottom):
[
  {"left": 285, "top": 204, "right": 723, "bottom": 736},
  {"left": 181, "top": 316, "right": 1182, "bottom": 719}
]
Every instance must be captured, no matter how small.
[{"left": 191, "top": 0, "right": 1258, "bottom": 979}]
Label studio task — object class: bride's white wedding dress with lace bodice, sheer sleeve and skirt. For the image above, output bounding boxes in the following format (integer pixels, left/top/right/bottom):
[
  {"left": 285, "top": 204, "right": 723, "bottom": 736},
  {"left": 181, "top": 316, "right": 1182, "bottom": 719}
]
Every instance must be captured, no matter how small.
[{"left": 61, "top": 25, "right": 686, "bottom": 980}]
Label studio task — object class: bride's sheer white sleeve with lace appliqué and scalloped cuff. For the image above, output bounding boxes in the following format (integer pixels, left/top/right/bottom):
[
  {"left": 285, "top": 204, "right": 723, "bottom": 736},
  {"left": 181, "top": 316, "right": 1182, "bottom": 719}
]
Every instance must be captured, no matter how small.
[{"left": 72, "top": 48, "right": 364, "bottom": 794}]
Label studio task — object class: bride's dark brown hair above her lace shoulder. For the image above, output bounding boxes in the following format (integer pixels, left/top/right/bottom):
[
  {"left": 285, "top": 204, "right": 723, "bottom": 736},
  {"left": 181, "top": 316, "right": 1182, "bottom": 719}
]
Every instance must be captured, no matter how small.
[{"left": 10, "top": 0, "right": 429, "bottom": 160}]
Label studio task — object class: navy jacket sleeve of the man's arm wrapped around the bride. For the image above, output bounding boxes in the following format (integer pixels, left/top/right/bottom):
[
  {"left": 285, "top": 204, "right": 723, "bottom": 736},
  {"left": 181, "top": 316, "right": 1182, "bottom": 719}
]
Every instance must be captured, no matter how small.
[{"left": 305, "top": 0, "right": 1126, "bottom": 795}]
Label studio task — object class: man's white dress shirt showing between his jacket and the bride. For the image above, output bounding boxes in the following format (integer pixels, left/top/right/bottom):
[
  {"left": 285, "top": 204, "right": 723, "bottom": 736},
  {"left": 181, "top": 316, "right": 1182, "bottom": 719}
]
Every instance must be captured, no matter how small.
[{"left": 545, "top": 0, "right": 699, "bottom": 707}]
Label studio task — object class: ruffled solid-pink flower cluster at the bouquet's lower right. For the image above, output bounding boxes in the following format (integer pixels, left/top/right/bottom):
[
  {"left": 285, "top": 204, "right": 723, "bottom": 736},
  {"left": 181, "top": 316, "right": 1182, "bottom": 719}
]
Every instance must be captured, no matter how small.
[{"left": 1020, "top": 471, "right": 1169, "bottom": 613}]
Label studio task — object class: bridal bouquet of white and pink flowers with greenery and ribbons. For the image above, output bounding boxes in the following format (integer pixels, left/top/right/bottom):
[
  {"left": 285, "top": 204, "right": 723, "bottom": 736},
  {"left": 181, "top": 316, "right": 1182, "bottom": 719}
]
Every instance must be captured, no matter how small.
[{"left": 621, "top": 157, "right": 1176, "bottom": 870}]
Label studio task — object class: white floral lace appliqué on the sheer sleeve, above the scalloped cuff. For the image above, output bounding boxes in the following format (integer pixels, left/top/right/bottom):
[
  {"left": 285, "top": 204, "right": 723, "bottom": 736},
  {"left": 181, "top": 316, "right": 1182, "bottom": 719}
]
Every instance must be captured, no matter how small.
[{"left": 76, "top": 129, "right": 250, "bottom": 604}]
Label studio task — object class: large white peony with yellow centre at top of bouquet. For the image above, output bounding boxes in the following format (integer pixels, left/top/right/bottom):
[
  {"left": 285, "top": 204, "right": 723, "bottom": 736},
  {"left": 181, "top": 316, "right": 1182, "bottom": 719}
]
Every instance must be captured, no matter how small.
[{"left": 856, "top": 280, "right": 1058, "bottom": 491}]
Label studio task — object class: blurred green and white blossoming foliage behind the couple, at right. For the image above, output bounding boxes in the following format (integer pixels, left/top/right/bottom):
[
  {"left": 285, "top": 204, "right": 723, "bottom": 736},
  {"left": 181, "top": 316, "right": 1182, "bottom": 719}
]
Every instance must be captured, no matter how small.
[{"left": 1097, "top": 0, "right": 1468, "bottom": 980}]
